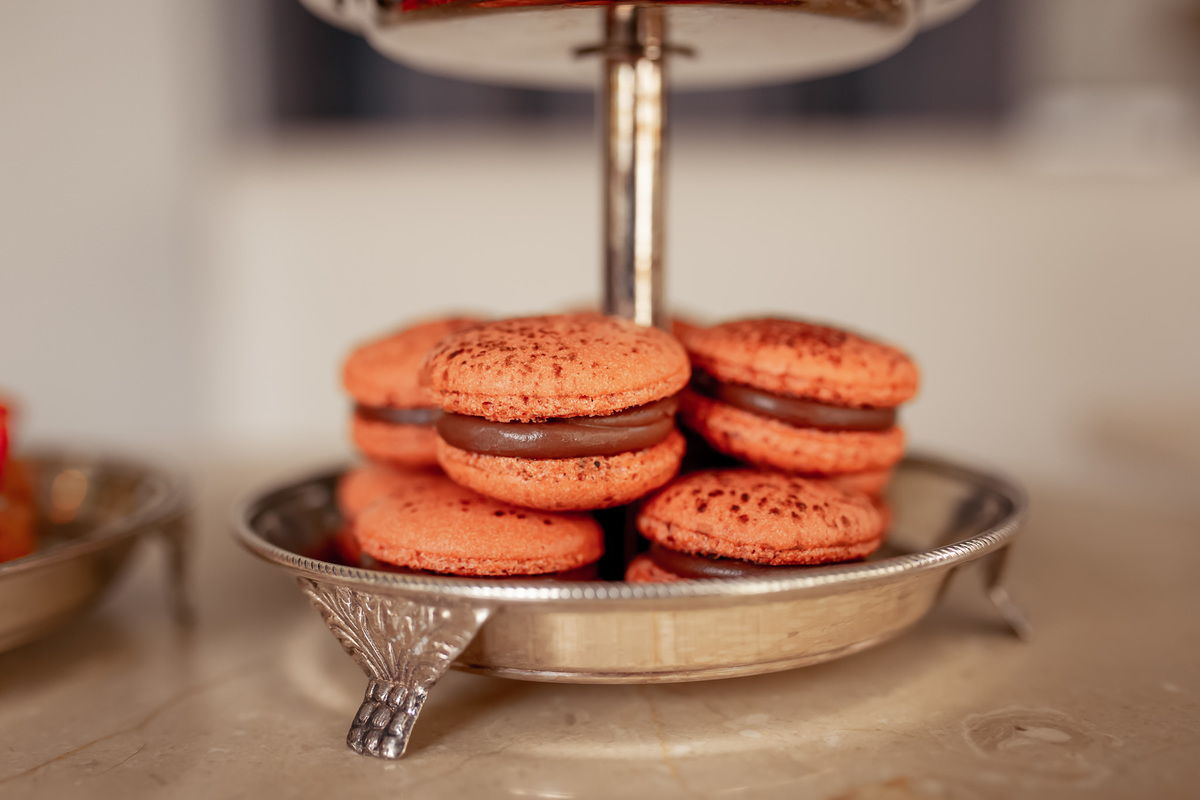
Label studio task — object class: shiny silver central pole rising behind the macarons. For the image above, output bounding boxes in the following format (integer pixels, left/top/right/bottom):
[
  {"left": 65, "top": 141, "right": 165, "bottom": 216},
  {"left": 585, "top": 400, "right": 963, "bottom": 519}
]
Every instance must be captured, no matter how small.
[{"left": 599, "top": 4, "right": 667, "bottom": 326}]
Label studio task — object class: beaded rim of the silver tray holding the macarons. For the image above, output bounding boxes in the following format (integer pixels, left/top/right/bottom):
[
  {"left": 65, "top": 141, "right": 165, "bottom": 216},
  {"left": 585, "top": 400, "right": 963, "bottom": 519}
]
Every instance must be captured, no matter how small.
[{"left": 233, "top": 453, "right": 1028, "bottom": 604}]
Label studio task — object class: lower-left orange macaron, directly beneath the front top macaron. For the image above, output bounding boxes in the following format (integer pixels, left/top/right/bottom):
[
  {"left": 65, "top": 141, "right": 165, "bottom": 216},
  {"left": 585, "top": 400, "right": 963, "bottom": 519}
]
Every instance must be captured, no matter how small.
[{"left": 355, "top": 477, "right": 604, "bottom": 577}]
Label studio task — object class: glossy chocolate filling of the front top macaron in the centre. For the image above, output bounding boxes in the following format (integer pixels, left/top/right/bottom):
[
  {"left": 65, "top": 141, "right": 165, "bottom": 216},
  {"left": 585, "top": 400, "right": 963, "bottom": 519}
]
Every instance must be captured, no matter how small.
[{"left": 437, "top": 397, "right": 679, "bottom": 458}]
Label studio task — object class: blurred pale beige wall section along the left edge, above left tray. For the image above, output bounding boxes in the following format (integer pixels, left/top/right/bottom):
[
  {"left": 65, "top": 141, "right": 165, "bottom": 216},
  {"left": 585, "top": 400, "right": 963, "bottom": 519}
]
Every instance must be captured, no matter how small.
[{"left": 0, "top": 0, "right": 215, "bottom": 460}]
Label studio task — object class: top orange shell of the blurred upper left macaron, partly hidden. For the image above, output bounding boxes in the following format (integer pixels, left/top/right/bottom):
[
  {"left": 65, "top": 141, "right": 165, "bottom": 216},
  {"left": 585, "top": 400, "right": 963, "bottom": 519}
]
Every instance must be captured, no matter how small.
[{"left": 342, "top": 317, "right": 479, "bottom": 408}]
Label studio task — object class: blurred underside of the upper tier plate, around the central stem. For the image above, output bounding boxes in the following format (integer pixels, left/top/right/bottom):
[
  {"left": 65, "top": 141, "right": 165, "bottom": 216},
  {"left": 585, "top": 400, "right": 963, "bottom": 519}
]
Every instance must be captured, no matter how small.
[{"left": 301, "top": 0, "right": 976, "bottom": 90}]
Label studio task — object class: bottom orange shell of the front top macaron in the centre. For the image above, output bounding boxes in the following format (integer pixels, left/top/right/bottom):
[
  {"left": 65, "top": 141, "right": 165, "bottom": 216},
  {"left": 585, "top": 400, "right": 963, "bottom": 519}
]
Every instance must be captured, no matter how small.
[{"left": 438, "top": 431, "right": 686, "bottom": 511}]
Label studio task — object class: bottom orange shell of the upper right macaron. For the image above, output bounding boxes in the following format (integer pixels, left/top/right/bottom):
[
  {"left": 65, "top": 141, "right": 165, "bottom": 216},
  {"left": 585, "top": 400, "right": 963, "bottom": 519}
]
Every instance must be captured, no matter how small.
[{"left": 679, "top": 390, "right": 904, "bottom": 475}]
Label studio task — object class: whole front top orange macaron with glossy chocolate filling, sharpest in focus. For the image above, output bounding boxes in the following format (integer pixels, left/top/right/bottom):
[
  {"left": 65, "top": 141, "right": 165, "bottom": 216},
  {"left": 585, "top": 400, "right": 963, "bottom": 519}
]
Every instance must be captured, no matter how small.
[{"left": 425, "top": 313, "right": 691, "bottom": 511}]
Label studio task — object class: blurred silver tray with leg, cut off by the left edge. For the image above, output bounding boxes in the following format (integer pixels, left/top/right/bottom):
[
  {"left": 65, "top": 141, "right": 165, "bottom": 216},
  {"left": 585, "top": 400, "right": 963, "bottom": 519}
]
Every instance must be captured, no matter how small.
[{"left": 0, "top": 451, "right": 187, "bottom": 652}]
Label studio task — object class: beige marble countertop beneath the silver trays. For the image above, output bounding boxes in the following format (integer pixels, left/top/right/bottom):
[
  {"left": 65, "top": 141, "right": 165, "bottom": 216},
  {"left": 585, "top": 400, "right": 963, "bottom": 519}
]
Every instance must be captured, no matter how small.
[{"left": 0, "top": 465, "right": 1200, "bottom": 800}]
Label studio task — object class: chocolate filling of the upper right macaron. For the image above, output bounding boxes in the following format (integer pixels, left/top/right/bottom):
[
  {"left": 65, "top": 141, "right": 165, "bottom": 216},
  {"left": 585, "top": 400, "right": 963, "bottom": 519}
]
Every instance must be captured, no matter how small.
[{"left": 691, "top": 371, "right": 896, "bottom": 431}]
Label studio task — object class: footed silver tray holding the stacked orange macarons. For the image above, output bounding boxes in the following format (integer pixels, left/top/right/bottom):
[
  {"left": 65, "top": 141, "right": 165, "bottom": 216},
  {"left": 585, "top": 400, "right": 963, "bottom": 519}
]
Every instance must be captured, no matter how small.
[{"left": 235, "top": 457, "right": 1026, "bottom": 758}]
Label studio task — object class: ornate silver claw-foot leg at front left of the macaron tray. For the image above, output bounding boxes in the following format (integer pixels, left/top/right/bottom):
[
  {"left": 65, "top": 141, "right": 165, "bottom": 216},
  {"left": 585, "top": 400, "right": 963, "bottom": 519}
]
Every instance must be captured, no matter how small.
[{"left": 299, "top": 578, "right": 492, "bottom": 758}]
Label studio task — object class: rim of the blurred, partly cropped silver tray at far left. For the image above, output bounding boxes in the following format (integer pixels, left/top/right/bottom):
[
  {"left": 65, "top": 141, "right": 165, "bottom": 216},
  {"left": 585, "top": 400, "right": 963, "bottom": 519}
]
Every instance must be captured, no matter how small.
[{"left": 0, "top": 445, "right": 187, "bottom": 582}]
